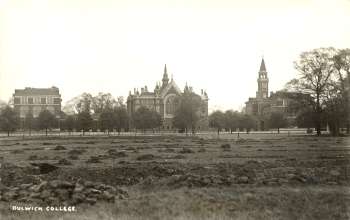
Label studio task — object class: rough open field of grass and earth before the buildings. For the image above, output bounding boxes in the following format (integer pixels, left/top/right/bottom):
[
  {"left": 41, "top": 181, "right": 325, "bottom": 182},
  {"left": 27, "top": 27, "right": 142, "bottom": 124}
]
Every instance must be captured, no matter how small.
[{"left": 0, "top": 134, "right": 350, "bottom": 219}]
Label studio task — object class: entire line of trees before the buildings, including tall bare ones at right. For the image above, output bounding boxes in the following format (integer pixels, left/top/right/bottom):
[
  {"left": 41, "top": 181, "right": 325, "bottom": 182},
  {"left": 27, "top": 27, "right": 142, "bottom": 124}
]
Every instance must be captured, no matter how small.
[{"left": 0, "top": 48, "right": 350, "bottom": 136}]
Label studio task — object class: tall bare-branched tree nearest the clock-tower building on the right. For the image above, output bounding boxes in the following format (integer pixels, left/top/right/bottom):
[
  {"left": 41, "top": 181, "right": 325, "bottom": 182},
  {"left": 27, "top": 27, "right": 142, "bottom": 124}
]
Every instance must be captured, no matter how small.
[{"left": 289, "top": 48, "right": 336, "bottom": 135}]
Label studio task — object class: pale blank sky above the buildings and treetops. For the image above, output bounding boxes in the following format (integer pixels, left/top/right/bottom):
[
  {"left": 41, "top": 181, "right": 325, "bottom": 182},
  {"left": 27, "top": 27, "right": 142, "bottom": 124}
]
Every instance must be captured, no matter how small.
[{"left": 0, "top": 0, "right": 350, "bottom": 110}]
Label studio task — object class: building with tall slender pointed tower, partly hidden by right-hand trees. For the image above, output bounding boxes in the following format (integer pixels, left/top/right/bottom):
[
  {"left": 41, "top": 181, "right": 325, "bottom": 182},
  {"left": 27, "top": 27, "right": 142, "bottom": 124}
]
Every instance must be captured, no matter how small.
[{"left": 245, "top": 59, "right": 309, "bottom": 130}]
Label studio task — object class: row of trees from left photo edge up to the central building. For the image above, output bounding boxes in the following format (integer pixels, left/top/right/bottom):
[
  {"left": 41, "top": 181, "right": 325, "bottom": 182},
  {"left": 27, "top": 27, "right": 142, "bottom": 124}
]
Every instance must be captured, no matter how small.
[{"left": 0, "top": 93, "right": 128, "bottom": 136}]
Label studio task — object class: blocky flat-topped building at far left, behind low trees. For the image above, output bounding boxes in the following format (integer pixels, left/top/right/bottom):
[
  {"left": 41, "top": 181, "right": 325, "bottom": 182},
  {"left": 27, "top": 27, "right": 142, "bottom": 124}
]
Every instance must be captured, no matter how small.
[{"left": 13, "top": 87, "right": 62, "bottom": 118}]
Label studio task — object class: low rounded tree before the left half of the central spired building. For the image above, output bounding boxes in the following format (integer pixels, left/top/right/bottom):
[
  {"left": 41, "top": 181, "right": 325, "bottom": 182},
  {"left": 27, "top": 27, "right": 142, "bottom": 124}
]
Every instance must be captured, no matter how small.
[{"left": 133, "top": 106, "right": 161, "bottom": 132}]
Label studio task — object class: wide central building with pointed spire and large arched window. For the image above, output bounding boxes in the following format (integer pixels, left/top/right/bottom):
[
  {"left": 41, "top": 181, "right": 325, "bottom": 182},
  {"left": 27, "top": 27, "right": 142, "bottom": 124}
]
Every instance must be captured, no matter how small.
[{"left": 127, "top": 65, "right": 208, "bottom": 130}]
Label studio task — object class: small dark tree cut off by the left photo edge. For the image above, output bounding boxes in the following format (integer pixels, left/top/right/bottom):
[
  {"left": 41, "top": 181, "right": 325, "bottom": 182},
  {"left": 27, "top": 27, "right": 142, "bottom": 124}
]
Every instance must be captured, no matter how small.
[{"left": 0, "top": 106, "right": 19, "bottom": 136}]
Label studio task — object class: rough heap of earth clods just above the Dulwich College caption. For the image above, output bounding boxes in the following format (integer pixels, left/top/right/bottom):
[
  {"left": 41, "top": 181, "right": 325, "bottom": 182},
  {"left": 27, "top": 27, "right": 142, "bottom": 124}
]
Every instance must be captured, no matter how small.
[{"left": 0, "top": 180, "right": 128, "bottom": 205}]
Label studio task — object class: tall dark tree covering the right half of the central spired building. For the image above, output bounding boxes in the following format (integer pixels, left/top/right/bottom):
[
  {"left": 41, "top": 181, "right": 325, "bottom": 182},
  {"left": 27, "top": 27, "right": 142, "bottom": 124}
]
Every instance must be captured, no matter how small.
[{"left": 173, "top": 90, "right": 201, "bottom": 134}]
